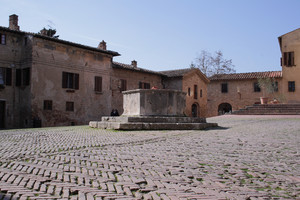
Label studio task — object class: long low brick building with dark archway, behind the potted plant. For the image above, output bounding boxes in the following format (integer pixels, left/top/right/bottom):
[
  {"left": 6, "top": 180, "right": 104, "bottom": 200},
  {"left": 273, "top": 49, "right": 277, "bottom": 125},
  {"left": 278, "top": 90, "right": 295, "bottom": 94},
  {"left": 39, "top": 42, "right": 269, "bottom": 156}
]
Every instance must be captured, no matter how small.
[{"left": 207, "top": 71, "right": 282, "bottom": 116}]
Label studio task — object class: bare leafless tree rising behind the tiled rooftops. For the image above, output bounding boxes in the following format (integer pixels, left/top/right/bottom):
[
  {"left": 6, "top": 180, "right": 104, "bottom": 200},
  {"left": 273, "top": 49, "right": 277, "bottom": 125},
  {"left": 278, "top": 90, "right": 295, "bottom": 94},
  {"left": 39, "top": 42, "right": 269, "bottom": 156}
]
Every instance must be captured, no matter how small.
[{"left": 191, "top": 50, "right": 235, "bottom": 77}]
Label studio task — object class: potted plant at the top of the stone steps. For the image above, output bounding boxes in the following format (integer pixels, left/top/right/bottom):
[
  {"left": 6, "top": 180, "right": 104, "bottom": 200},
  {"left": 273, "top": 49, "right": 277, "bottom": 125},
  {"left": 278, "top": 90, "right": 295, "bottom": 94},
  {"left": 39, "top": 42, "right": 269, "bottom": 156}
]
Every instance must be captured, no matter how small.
[{"left": 258, "top": 77, "right": 276, "bottom": 104}]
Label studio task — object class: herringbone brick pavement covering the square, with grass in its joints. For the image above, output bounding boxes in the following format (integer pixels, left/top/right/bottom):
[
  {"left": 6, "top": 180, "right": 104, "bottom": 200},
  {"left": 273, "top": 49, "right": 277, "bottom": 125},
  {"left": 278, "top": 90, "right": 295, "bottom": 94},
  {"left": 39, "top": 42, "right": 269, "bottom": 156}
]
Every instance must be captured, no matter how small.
[{"left": 0, "top": 116, "right": 300, "bottom": 200}]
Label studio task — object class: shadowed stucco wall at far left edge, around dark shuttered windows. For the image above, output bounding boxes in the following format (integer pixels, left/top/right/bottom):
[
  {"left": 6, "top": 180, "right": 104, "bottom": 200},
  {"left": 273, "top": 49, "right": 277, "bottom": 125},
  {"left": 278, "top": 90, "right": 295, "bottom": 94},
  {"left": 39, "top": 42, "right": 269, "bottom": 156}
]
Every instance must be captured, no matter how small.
[{"left": 0, "top": 30, "right": 31, "bottom": 128}]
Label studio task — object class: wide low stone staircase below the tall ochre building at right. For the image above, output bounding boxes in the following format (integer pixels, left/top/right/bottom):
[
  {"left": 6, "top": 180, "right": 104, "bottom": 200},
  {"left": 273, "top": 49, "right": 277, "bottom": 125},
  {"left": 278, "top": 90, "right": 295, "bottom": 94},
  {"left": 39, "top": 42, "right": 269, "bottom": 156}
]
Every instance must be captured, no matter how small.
[{"left": 232, "top": 104, "right": 300, "bottom": 115}]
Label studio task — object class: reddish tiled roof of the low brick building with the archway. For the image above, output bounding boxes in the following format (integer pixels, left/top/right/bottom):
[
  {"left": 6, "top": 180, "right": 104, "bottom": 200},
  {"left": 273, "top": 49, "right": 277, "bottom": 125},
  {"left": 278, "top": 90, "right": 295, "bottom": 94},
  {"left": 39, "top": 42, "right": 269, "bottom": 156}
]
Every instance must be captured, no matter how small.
[{"left": 209, "top": 71, "right": 282, "bottom": 81}]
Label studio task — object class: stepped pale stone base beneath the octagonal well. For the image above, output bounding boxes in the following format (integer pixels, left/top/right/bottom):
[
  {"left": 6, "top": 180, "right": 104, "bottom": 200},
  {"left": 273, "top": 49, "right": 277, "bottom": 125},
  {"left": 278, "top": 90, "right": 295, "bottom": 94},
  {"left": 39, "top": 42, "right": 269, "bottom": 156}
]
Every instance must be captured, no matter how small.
[{"left": 89, "top": 116, "right": 218, "bottom": 130}]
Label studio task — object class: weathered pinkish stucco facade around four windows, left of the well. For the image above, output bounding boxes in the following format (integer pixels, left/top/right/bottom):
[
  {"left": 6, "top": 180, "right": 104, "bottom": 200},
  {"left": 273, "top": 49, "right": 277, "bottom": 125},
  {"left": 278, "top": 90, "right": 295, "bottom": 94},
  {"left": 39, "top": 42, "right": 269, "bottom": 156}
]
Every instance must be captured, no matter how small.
[{"left": 31, "top": 38, "right": 112, "bottom": 126}]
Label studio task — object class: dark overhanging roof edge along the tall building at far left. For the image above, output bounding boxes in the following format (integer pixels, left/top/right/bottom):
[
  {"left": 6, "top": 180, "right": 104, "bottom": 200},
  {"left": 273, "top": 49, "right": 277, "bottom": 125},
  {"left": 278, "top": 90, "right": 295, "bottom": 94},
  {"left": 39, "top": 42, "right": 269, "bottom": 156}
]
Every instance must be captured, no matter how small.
[{"left": 0, "top": 26, "right": 120, "bottom": 56}]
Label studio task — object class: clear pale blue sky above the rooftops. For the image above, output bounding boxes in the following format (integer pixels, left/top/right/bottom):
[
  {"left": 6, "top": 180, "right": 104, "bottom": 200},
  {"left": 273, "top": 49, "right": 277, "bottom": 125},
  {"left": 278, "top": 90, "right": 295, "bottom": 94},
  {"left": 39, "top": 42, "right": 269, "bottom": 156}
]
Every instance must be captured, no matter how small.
[{"left": 0, "top": 0, "right": 300, "bottom": 72}]
